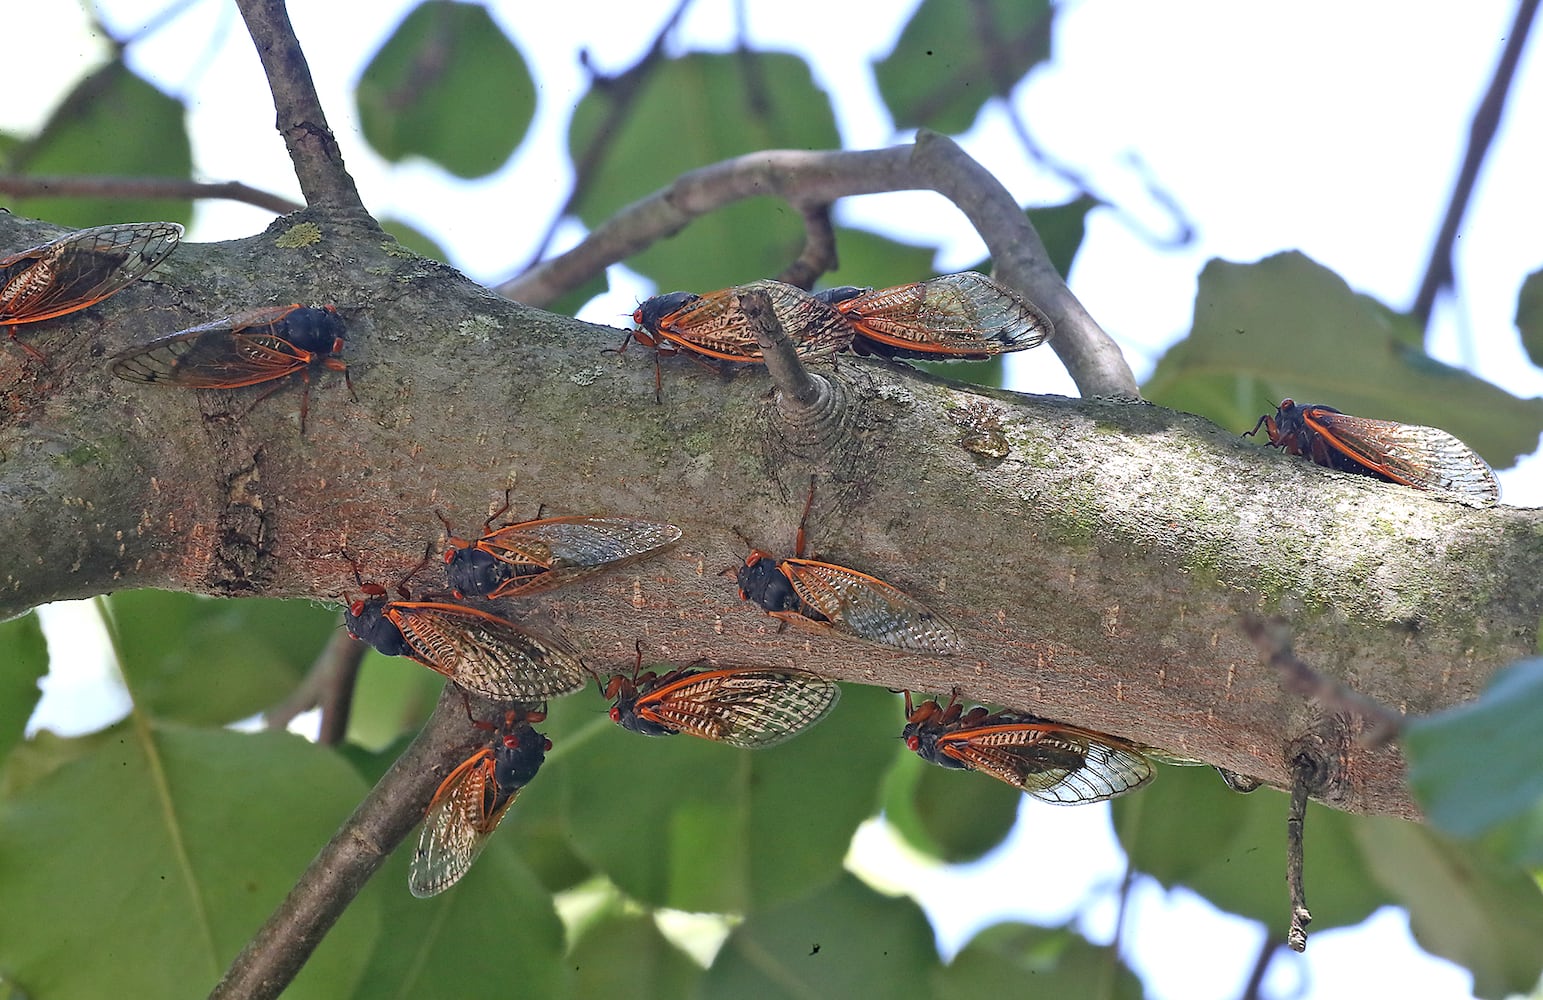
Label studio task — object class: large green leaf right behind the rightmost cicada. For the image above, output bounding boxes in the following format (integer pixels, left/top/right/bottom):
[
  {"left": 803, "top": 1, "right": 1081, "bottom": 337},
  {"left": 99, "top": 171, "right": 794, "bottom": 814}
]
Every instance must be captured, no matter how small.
[{"left": 1142, "top": 253, "right": 1543, "bottom": 468}]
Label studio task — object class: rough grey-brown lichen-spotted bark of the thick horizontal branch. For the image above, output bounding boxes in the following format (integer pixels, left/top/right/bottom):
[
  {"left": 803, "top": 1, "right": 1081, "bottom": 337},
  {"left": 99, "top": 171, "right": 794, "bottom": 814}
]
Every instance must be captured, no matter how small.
[{"left": 0, "top": 210, "right": 1543, "bottom": 815}]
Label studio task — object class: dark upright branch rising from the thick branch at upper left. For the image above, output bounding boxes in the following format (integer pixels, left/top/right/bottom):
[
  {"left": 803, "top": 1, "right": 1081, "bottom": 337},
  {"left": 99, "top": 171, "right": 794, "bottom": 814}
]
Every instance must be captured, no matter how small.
[{"left": 236, "top": 0, "right": 367, "bottom": 215}]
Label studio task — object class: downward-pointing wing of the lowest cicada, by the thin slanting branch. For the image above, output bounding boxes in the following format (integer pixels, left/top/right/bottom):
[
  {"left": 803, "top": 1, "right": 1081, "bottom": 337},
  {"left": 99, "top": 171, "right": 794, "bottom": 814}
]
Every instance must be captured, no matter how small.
[{"left": 407, "top": 748, "right": 518, "bottom": 898}]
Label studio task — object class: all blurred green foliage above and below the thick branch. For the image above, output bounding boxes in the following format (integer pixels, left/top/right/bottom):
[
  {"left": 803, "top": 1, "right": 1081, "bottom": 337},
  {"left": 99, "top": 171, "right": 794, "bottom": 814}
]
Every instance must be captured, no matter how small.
[{"left": 0, "top": 0, "right": 1543, "bottom": 998}]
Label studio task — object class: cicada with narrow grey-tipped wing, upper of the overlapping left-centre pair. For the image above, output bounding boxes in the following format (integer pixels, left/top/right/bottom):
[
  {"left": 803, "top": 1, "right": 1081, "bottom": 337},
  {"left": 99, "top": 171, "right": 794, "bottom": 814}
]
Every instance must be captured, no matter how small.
[{"left": 444, "top": 497, "right": 680, "bottom": 599}]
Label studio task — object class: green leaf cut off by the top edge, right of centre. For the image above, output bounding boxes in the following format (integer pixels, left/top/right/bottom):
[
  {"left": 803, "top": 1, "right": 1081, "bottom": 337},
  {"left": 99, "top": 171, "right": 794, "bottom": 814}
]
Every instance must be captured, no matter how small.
[{"left": 873, "top": 0, "right": 1054, "bottom": 133}]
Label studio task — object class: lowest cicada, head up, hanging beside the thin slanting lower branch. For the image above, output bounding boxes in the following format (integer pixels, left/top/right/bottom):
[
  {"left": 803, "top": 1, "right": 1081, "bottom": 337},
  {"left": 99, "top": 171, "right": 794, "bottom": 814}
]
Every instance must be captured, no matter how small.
[{"left": 407, "top": 708, "right": 552, "bottom": 898}]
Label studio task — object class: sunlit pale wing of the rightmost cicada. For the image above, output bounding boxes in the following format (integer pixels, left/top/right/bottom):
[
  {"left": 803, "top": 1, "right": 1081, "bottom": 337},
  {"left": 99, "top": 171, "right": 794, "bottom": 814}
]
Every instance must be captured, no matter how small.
[{"left": 1305, "top": 410, "right": 1500, "bottom": 506}]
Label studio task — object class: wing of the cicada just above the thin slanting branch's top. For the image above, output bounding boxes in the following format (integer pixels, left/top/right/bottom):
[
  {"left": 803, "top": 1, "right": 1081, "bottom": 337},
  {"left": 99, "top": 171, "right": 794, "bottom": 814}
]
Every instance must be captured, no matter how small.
[{"left": 386, "top": 600, "right": 589, "bottom": 701}]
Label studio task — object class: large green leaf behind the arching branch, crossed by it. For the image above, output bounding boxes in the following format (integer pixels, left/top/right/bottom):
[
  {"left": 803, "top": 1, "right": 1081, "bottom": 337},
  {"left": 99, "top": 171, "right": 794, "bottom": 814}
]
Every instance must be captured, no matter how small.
[{"left": 568, "top": 52, "right": 841, "bottom": 292}]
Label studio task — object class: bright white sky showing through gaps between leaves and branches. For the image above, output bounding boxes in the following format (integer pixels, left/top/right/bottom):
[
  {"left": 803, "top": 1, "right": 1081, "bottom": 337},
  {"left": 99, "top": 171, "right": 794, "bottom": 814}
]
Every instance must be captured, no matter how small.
[{"left": 12, "top": 0, "right": 1543, "bottom": 1000}]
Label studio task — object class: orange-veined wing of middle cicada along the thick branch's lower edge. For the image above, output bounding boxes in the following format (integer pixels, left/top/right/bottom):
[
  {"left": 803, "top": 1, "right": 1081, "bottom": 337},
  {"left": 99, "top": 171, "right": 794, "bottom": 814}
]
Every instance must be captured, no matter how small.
[{"left": 637, "top": 667, "right": 841, "bottom": 750}]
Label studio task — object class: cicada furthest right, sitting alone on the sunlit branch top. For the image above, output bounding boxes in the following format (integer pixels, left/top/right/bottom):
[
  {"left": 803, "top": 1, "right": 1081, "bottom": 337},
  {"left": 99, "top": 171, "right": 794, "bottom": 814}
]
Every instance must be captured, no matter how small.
[{"left": 1247, "top": 400, "right": 1500, "bottom": 506}]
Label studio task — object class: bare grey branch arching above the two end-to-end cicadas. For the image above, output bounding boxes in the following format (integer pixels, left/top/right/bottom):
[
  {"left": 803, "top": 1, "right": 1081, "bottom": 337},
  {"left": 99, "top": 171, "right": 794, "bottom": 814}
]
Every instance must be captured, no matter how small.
[{"left": 498, "top": 133, "right": 1139, "bottom": 397}]
